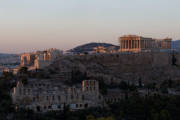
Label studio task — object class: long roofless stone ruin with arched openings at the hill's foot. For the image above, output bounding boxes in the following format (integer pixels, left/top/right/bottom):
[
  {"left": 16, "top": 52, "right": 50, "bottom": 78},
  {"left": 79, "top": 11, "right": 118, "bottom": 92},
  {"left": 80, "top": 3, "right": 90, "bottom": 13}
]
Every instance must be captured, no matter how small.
[{"left": 12, "top": 80, "right": 103, "bottom": 112}]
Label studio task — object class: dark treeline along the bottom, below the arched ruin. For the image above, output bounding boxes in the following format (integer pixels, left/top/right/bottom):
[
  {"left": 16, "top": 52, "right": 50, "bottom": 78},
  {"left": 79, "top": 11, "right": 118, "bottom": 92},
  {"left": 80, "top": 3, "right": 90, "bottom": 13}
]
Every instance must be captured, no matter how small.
[{"left": 6, "top": 95, "right": 180, "bottom": 120}]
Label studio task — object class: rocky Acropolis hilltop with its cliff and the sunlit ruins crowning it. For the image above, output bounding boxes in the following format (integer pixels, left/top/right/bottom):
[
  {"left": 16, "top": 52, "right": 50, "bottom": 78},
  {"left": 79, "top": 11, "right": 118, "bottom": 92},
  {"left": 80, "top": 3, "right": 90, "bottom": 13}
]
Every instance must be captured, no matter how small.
[{"left": 17, "top": 35, "right": 177, "bottom": 84}]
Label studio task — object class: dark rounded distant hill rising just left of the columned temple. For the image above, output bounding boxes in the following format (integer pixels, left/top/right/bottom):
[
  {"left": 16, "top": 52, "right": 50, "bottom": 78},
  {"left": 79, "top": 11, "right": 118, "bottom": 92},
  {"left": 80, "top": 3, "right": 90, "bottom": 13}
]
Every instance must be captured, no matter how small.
[{"left": 68, "top": 42, "right": 119, "bottom": 53}]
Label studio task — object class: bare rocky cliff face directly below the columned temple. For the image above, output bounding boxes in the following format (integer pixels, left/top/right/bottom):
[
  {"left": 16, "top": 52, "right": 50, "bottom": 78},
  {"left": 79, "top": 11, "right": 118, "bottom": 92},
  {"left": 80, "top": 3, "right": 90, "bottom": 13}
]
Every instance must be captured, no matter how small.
[{"left": 51, "top": 53, "right": 180, "bottom": 84}]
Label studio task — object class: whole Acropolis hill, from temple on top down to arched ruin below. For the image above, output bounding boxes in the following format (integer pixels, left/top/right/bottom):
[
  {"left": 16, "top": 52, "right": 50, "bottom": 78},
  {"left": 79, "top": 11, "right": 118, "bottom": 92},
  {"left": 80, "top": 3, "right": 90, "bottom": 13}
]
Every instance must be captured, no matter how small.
[{"left": 8, "top": 35, "right": 180, "bottom": 112}]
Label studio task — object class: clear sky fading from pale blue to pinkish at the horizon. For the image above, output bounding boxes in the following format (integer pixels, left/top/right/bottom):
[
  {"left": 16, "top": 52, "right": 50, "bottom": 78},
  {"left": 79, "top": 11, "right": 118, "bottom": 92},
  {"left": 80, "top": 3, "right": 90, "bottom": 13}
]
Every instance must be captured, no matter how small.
[{"left": 0, "top": 0, "right": 180, "bottom": 53}]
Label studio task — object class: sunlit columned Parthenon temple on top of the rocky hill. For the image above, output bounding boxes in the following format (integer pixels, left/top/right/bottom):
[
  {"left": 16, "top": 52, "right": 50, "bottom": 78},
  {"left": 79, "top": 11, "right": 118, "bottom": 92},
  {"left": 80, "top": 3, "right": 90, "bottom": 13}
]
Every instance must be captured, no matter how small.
[{"left": 119, "top": 35, "right": 172, "bottom": 52}]
